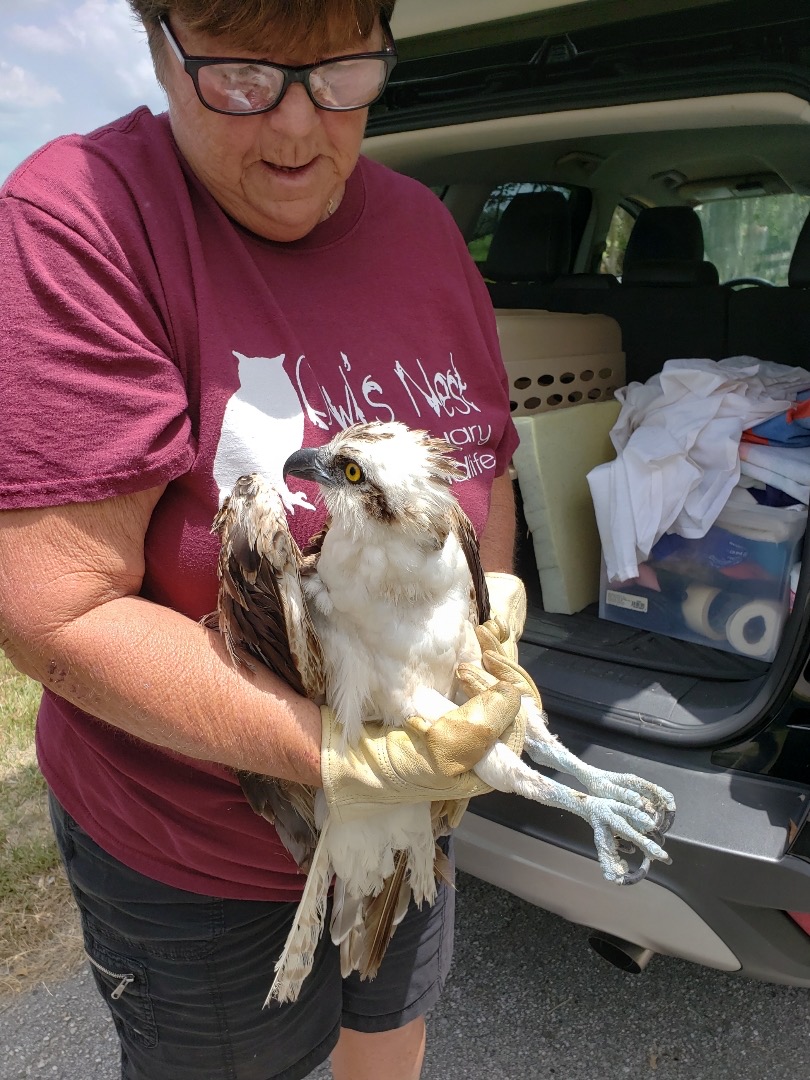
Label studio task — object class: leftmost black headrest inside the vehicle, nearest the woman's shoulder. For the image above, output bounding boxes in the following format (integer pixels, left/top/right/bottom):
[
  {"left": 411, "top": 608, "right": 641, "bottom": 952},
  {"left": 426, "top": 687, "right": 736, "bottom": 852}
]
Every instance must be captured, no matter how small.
[{"left": 482, "top": 191, "right": 571, "bottom": 282}]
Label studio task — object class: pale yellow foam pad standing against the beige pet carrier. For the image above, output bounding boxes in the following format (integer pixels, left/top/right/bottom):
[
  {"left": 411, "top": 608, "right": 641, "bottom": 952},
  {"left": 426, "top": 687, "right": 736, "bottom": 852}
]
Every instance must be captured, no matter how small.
[{"left": 512, "top": 401, "right": 621, "bottom": 615}]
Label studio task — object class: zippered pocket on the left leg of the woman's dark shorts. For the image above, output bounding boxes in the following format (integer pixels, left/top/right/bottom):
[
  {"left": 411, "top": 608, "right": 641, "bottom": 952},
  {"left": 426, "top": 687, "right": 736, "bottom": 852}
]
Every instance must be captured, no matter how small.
[{"left": 84, "top": 932, "right": 158, "bottom": 1047}]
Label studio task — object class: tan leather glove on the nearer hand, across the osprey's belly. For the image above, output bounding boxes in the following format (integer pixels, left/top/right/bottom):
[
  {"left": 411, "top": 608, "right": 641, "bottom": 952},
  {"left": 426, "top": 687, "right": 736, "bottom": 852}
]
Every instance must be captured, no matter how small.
[{"left": 321, "top": 685, "right": 526, "bottom": 822}]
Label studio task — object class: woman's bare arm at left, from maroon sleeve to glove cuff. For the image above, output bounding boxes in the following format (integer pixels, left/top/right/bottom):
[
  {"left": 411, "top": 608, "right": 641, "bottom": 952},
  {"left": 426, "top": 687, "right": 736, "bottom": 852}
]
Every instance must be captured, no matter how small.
[{"left": 0, "top": 488, "right": 321, "bottom": 784}]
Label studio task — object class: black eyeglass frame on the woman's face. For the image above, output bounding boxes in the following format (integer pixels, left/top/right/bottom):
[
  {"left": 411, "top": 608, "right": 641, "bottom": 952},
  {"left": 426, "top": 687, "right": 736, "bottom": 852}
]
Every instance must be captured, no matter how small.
[{"left": 158, "top": 12, "right": 399, "bottom": 117}]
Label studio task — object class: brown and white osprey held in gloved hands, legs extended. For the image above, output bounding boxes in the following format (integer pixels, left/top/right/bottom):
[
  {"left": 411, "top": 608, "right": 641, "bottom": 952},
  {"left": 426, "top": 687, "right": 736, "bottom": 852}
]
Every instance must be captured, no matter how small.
[{"left": 212, "top": 421, "right": 675, "bottom": 1001}]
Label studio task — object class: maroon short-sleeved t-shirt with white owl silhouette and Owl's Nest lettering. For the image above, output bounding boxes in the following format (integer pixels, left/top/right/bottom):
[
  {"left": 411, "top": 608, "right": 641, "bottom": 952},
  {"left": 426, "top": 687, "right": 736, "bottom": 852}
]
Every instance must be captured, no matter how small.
[{"left": 0, "top": 109, "right": 516, "bottom": 900}]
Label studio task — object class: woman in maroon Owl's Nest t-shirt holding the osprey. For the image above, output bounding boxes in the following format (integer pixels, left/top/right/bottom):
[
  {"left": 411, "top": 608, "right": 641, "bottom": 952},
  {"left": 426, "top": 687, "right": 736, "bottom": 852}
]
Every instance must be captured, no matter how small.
[{"left": 0, "top": 0, "right": 516, "bottom": 1080}]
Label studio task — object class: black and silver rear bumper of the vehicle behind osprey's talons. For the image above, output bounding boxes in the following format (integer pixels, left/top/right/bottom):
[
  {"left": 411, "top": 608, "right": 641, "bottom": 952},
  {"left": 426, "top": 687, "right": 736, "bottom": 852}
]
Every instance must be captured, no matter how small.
[{"left": 456, "top": 737, "right": 810, "bottom": 986}]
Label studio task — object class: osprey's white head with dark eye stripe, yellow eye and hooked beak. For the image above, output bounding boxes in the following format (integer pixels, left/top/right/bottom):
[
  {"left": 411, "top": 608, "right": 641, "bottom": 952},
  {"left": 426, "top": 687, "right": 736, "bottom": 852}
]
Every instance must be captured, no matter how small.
[{"left": 284, "top": 421, "right": 464, "bottom": 542}]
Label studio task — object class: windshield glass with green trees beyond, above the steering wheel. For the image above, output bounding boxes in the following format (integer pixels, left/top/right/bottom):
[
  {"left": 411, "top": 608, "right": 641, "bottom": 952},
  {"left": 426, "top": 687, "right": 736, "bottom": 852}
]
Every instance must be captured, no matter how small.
[{"left": 696, "top": 194, "right": 810, "bottom": 285}]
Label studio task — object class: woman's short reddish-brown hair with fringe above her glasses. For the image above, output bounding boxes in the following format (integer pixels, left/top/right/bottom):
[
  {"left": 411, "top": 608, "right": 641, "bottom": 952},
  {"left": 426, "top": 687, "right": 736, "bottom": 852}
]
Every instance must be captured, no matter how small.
[{"left": 129, "top": 0, "right": 396, "bottom": 78}]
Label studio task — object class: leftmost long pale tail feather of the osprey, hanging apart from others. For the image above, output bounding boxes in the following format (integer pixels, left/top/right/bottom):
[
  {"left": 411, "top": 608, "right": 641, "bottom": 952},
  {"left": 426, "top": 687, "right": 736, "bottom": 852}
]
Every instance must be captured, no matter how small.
[{"left": 265, "top": 818, "right": 333, "bottom": 1007}]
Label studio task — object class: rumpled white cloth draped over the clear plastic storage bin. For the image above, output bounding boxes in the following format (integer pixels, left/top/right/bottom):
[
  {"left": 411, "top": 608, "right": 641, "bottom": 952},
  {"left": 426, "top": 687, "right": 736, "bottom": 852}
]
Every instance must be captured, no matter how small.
[{"left": 588, "top": 356, "right": 810, "bottom": 581}]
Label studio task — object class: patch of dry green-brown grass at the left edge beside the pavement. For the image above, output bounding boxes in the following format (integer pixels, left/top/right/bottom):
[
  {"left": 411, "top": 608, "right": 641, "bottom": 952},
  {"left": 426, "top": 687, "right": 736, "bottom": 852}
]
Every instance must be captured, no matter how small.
[{"left": 0, "top": 652, "right": 82, "bottom": 997}]
